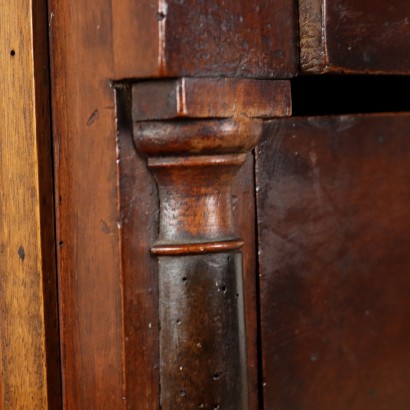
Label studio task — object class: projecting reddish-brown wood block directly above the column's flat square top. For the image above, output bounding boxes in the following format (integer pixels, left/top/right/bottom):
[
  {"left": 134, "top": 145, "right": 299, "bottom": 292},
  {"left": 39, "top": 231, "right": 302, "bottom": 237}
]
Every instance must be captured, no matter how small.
[{"left": 112, "top": 0, "right": 297, "bottom": 79}]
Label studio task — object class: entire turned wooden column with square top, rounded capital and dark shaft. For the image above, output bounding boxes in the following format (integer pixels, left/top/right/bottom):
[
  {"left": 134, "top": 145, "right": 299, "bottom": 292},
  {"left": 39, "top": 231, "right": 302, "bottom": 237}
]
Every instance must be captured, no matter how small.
[{"left": 133, "top": 79, "right": 289, "bottom": 410}]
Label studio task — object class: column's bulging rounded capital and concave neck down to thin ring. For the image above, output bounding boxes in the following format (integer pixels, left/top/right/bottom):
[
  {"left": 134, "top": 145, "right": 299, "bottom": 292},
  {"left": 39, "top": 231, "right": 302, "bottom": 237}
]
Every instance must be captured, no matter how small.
[{"left": 134, "top": 117, "right": 261, "bottom": 254}]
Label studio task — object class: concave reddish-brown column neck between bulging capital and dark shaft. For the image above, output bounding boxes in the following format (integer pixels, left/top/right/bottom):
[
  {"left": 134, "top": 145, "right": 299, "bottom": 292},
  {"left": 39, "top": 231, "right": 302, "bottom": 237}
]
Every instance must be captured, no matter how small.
[{"left": 148, "top": 154, "right": 246, "bottom": 250}]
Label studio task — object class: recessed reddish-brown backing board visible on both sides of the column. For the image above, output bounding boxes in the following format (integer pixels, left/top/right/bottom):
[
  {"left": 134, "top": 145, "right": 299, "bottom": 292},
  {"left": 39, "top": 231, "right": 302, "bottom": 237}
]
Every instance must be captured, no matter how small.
[{"left": 117, "top": 86, "right": 258, "bottom": 409}]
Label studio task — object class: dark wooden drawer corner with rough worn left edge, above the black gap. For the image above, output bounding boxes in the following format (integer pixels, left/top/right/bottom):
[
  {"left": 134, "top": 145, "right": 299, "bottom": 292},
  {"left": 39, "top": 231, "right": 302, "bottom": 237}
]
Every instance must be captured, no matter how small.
[{"left": 299, "top": 0, "right": 410, "bottom": 73}]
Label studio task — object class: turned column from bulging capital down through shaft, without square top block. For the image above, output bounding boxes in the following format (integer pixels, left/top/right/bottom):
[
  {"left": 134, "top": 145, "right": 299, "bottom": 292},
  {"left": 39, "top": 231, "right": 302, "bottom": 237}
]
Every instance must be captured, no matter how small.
[{"left": 134, "top": 117, "right": 261, "bottom": 409}]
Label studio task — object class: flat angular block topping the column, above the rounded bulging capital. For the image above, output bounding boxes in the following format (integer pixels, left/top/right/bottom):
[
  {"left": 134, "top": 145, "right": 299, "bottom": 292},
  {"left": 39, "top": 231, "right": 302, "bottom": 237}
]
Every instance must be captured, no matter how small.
[{"left": 132, "top": 78, "right": 290, "bottom": 121}]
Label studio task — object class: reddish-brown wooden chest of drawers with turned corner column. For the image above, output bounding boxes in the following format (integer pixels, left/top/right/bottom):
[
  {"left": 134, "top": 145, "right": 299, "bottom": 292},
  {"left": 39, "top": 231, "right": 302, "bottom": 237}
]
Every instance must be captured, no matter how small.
[{"left": 0, "top": 0, "right": 410, "bottom": 410}]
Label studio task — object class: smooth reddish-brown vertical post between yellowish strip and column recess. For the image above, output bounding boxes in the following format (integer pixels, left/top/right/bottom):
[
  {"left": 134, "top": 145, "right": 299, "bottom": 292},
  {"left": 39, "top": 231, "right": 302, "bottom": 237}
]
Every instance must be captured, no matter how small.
[{"left": 49, "top": 0, "right": 126, "bottom": 410}]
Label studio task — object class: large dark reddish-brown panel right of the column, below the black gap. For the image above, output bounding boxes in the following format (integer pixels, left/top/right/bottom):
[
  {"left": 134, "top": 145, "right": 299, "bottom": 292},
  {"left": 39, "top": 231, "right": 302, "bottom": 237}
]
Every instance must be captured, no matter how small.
[{"left": 256, "top": 114, "right": 410, "bottom": 410}]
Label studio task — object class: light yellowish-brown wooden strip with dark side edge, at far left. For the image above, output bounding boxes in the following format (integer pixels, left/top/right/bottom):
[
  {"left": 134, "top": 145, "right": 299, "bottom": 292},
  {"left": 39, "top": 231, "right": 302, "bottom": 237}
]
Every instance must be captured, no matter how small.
[{"left": 0, "top": 1, "right": 60, "bottom": 410}]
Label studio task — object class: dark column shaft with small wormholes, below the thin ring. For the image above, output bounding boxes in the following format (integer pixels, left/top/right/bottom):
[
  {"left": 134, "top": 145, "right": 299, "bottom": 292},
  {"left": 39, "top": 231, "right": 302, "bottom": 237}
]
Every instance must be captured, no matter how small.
[{"left": 159, "top": 253, "right": 249, "bottom": 410}]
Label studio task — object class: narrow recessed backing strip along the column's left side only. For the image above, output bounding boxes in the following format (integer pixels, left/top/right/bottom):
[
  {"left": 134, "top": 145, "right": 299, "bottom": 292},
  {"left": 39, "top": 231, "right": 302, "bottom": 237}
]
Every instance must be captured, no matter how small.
[{"left": 116, "top": 87, "right": 160, "bottom": 410}]
